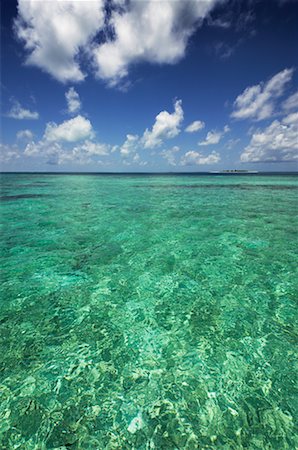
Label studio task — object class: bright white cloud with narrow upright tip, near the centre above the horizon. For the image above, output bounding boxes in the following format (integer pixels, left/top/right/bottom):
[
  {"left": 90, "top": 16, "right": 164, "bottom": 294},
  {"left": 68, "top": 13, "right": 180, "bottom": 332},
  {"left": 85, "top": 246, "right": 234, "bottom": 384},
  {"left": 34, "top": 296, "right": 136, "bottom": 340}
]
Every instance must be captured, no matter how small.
[{"left": 142, "top": 100, "right": 183, "bottom": 148}]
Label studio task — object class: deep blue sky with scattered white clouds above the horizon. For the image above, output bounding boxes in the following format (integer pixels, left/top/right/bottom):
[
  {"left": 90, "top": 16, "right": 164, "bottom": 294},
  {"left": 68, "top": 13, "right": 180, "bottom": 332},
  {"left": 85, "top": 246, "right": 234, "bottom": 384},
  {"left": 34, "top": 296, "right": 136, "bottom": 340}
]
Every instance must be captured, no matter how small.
[{"left": 0, "top": 0, "right": 298, "bottom": 172}]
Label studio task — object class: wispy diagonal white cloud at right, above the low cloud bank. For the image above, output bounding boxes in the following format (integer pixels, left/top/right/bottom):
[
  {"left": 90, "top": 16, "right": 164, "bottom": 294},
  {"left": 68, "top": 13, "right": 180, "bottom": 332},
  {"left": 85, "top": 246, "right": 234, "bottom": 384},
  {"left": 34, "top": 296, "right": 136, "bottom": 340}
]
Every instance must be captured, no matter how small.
[{"left": 231, "top": 69, "right": 293, "bottom": 120}]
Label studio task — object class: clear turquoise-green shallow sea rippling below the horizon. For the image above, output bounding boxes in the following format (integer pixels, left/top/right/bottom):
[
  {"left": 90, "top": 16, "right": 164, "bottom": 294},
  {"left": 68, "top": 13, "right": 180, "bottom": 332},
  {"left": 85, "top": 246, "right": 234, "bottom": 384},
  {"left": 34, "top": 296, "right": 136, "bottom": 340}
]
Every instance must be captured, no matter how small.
[{"left": 0, "top": 174, "right": 298, "bottom": 450}]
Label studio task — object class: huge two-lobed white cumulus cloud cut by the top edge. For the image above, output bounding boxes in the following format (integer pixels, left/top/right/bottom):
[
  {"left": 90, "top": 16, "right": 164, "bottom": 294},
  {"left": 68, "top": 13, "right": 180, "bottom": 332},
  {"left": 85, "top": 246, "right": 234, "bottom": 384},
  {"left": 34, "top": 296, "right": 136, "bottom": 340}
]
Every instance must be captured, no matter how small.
[{"left": 14, "top": 0, "right": 220, "bottom": 84}]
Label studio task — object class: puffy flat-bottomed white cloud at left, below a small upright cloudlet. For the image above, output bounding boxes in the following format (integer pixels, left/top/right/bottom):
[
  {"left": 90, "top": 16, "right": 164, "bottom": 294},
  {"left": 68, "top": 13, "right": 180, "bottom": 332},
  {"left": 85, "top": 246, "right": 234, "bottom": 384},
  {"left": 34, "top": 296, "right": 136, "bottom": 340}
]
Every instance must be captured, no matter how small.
[{"left": 44, "top": 115, "right": 94, "bottom": 142}]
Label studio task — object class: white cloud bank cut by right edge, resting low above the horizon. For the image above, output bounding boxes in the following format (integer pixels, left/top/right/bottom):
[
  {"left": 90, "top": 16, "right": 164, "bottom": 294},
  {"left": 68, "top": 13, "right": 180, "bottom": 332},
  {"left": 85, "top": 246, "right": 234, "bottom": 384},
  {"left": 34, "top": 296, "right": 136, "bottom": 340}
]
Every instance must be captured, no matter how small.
[{"left": 240, "top": 112, "right": 298, "bottom": 162}]
